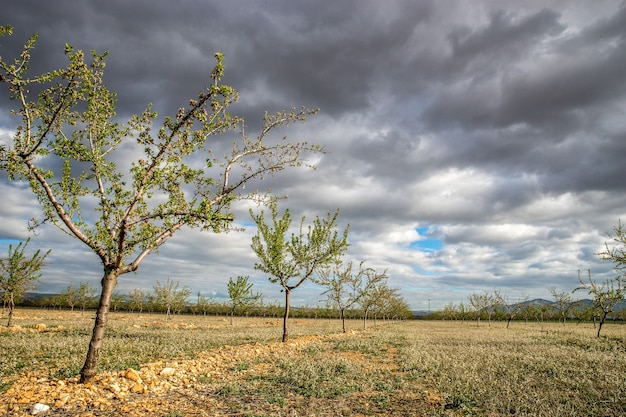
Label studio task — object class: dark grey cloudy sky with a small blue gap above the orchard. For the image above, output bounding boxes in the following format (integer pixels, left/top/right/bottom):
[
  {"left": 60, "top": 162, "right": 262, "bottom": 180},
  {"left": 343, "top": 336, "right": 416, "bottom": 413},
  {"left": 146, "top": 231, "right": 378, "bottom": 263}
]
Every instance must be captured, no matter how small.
[{"left": 0, "top": 0, "right": 626, "bottom": 309}]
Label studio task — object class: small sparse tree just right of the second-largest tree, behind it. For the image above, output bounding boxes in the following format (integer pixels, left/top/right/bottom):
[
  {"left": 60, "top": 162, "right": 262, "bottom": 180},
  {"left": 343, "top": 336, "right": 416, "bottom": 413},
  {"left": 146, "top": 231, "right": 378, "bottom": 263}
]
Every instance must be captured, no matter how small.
[{"left": 316, "top": 261, "right": 387, "bottom": 333}]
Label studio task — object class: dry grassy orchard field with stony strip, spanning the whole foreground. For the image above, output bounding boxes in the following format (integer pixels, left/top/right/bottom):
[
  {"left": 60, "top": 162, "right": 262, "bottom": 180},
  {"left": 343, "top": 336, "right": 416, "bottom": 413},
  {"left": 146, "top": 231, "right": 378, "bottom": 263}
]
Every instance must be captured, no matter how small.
[{"left": 0, "top": 309, "right": 626, "bottom": 417}]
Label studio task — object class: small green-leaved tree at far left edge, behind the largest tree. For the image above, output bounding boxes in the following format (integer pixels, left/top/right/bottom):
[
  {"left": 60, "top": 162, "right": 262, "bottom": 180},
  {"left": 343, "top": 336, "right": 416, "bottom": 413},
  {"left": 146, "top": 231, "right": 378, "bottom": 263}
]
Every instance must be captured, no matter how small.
[{"left": 0, "top": 238, "right": 50, "bottom": 327}]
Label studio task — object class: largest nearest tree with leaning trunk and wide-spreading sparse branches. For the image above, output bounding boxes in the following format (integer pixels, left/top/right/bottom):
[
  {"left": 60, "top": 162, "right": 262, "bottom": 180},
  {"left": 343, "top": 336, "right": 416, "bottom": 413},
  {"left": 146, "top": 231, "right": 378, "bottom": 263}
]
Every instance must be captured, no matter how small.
[{"left": 0, "top": 27, "right": 324, "bottom": 382}]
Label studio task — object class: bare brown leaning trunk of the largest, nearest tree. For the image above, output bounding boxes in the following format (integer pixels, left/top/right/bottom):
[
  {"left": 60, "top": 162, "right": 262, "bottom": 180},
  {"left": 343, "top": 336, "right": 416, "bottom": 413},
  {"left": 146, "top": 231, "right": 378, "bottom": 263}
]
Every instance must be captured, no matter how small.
[{"left": 80, "top": 268, "right": 118, "bottom": 383}]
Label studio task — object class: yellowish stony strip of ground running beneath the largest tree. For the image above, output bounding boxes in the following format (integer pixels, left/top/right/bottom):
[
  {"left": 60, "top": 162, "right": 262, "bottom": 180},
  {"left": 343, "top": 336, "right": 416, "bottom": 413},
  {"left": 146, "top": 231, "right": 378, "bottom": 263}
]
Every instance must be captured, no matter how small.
[{"left": 0, "top": 328, "right": 444, "bottom": 417}]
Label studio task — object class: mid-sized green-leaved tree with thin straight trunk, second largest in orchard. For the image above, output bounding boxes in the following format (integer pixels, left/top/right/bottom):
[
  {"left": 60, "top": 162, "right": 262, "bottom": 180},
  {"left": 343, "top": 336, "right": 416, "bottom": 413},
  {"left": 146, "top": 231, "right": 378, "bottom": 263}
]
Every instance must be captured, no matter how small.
[{"left": 250, "top": 203, "right": 348, "bottom": 342}]
